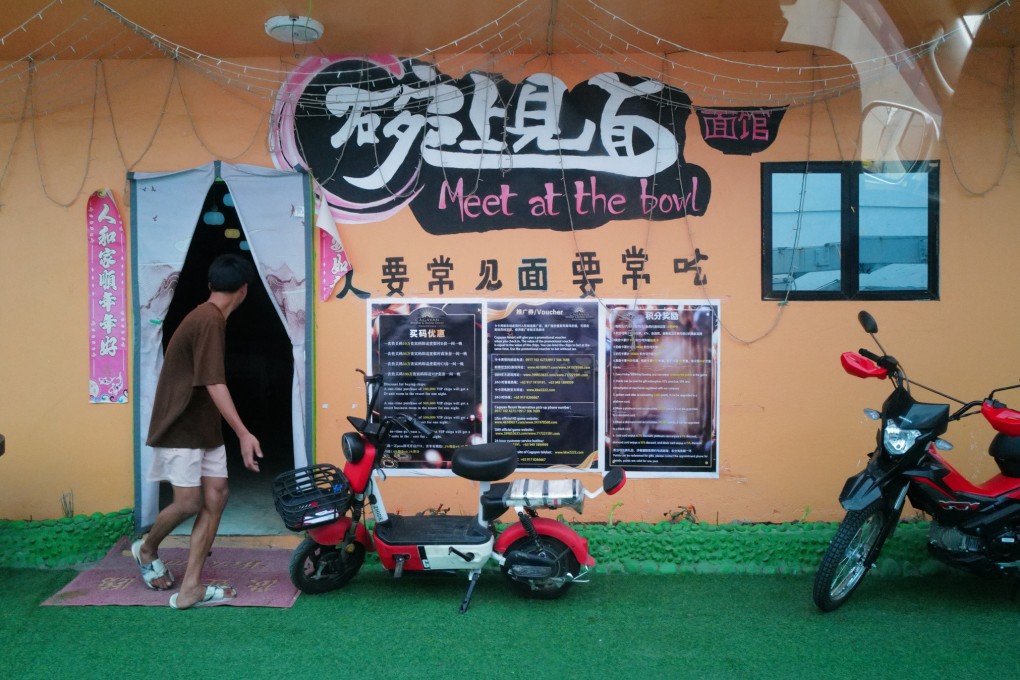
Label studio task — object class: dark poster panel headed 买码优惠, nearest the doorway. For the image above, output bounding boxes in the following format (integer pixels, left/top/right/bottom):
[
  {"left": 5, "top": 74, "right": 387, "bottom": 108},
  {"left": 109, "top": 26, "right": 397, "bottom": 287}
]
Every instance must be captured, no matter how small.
[{"left": 369, "top": 301, "right": 482, "bottom": 471}]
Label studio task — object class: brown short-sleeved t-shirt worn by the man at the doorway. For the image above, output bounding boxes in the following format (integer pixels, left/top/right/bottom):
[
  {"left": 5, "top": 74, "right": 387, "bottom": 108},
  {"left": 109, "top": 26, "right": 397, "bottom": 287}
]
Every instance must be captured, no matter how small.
[{"left": 146, "top": 302, "right": 226, "bottom": 449}]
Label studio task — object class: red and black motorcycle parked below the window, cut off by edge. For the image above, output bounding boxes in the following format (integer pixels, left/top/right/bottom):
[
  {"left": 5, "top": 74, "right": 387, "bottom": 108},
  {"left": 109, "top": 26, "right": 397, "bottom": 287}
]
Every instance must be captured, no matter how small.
[{"left": 813, "top": 312, "right": 1020, "bottom": 612}]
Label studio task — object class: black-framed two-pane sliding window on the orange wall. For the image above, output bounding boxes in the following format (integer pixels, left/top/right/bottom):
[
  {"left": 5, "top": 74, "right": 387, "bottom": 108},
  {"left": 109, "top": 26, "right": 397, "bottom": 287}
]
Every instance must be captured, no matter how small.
[{"left": 762, "top": 161, "right": 938, "bottom": 300}]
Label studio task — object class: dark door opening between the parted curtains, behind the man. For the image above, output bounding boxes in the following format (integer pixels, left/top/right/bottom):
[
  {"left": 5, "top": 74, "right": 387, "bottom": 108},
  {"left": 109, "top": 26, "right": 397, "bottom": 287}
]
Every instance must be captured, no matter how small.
[{"left": 159, "top": 179, "right": 294, "bottom": 535}]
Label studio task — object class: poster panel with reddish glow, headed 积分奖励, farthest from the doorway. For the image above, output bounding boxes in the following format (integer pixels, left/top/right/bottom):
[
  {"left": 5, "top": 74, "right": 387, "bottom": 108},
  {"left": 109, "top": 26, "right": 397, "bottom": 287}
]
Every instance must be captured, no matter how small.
[{"left": 606, "top": 301, "right": 719, "bottom": 477}]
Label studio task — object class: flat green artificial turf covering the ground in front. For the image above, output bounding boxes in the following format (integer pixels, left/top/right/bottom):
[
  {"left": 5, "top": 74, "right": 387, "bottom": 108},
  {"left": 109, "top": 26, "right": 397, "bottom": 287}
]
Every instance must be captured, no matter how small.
[{"left": 0, "top": 565, "right": 1020, "bottom": 680}]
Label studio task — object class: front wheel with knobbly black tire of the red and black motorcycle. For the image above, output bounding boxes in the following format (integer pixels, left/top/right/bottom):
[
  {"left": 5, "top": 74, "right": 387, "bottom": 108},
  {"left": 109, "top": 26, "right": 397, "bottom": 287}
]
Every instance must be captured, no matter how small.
[{"left": 812, "top": 503, "right": 893, "bottom": 612}]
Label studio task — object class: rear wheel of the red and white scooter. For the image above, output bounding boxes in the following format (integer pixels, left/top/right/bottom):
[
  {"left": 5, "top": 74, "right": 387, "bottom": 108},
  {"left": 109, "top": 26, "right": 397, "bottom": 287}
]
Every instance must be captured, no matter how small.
[{"left": 503, "top": 535, "right": 580, "bottom": 599}]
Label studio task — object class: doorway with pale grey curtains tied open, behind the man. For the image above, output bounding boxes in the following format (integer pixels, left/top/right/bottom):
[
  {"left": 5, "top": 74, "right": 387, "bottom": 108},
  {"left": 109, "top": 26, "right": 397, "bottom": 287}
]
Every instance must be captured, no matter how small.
[{"left": 129, "top": 161, "right": 313, "bottom": 534}]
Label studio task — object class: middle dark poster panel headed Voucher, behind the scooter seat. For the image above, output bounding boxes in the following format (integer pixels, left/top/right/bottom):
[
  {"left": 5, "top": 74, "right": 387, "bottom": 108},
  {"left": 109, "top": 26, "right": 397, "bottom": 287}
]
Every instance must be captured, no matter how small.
[{"left": 486, "top": 301, "right": 600, "bottom": 469}]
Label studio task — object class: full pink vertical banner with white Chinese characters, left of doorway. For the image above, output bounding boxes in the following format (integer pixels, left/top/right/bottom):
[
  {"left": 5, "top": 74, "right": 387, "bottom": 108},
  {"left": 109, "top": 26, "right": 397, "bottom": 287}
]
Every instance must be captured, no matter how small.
[{"left": 87, "top": 189, "right": 128, "bottom": 404}]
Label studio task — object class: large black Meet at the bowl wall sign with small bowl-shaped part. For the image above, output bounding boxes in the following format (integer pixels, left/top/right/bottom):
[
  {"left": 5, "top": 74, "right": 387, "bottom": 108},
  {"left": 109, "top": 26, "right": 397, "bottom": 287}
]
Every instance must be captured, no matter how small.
[{"left": 270, "top": 55, "right": 783, "bottom": 234}]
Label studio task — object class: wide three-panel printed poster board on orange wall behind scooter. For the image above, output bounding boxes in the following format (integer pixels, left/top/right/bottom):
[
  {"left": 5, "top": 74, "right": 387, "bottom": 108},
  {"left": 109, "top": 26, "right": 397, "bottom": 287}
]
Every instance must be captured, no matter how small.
[{"left": 368, "top": 299, "right": 719, "bottom": 477}]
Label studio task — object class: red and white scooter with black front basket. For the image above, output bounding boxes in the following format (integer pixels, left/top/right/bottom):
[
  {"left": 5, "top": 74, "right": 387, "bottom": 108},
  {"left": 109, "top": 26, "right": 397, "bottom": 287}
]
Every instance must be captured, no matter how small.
[{"left": 272, "top": 370, "right": 626, "bottom": 613}]
